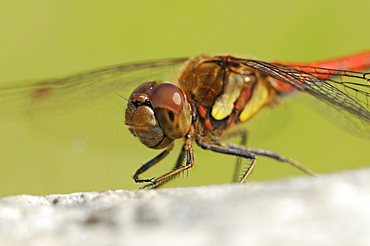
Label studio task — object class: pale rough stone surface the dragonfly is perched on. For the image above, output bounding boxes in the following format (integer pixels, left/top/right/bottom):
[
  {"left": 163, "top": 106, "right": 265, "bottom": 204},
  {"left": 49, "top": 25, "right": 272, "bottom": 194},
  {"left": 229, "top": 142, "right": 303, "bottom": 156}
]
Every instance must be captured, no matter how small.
[{"left": 0, "top": 169, "right": 370, "bottom": 246}]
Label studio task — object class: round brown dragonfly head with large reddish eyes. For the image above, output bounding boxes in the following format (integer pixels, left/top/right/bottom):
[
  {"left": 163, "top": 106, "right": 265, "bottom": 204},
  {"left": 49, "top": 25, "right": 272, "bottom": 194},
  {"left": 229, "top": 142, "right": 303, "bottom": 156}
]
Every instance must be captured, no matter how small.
[{"left": 125, "top": 82, "right": 192, "bottom": 149}]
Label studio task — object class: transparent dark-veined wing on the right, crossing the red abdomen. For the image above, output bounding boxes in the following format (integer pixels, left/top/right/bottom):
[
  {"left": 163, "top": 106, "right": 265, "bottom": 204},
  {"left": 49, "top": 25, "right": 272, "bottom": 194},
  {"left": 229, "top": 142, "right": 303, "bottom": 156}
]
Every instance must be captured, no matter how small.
[{"left": 231, "top": 59, "right": 370, "bottom": 138}]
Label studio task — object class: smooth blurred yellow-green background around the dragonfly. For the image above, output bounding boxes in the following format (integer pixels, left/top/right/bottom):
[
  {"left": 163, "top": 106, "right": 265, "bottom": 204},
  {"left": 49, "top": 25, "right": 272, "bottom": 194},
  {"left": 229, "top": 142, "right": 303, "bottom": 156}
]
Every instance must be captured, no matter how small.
[{"left": 0, "top": 0, "right": 370, "bottom": 196}]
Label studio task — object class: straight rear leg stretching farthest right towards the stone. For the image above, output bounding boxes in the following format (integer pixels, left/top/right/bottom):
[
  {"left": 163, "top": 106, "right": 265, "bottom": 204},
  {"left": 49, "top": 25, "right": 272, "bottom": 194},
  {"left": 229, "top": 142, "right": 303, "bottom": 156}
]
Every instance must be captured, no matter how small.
[{"left": 225, "top": 143, "right": 320, "bottom": 176}]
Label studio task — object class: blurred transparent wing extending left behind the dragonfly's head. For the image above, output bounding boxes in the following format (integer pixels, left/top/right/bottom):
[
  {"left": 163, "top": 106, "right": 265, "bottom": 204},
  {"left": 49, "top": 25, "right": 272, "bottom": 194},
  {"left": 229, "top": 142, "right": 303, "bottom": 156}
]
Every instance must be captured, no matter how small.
[{"left": 0, "top": 59, "right": 186, "bottom": 148}]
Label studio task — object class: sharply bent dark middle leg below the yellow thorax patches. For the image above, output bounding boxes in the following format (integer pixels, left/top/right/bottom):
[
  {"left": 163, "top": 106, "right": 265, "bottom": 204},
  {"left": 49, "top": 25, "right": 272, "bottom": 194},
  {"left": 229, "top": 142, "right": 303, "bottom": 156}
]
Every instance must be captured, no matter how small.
[{"left": 197, "top": 139, "right": 257, "bottom": 183}]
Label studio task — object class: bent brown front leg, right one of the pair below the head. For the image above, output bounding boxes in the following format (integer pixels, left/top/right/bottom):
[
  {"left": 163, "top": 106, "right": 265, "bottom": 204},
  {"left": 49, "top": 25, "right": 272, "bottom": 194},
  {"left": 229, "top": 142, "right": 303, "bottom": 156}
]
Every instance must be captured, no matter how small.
[{"left": 140, "top": 128, "right": 194, "bottom": 189}]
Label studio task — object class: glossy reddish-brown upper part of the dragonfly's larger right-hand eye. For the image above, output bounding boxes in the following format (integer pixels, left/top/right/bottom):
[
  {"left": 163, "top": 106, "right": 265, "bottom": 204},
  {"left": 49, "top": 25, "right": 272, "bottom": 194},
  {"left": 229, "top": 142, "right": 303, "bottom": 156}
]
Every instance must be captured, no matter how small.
[{"left": 148, "top": 83, "right": 185, "bottom": 113}]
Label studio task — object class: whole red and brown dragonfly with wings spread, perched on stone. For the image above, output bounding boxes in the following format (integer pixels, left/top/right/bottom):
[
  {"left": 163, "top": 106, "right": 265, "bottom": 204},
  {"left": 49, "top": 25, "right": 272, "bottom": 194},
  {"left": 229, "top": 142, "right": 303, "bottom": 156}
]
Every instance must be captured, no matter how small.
[{"left": 0, "top": 51, "right": 370, "bottom": 189}]
